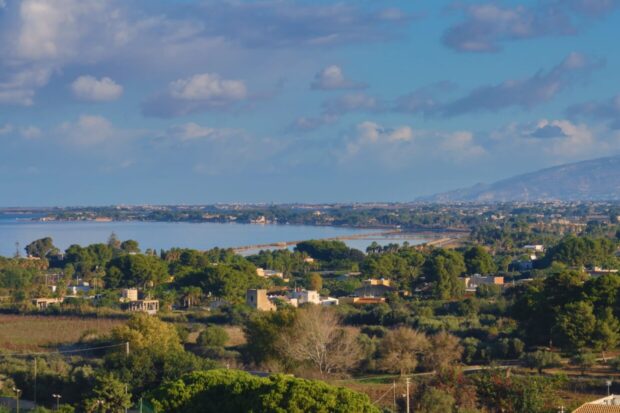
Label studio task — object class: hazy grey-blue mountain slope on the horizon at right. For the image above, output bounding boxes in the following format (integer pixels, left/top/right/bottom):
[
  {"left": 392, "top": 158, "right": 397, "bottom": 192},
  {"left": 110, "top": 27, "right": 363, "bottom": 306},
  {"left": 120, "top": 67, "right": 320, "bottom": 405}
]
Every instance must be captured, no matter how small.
[{"left": 420, "top": 156, "right": 620, "bottom": 202}]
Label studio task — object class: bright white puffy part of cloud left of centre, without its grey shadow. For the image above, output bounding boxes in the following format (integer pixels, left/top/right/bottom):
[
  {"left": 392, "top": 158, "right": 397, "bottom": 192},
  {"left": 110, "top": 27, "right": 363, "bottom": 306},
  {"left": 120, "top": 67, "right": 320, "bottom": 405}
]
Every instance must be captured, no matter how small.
[{"left": 169, "top": 73, "right": 247, "bottom": 103}]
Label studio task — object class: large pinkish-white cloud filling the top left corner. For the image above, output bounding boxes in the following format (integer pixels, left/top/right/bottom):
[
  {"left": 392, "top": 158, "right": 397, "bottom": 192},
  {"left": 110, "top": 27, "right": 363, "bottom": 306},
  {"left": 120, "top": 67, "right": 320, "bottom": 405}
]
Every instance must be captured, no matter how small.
[{"left": 0, "top": 0, "right": 132, "bottom": 106}]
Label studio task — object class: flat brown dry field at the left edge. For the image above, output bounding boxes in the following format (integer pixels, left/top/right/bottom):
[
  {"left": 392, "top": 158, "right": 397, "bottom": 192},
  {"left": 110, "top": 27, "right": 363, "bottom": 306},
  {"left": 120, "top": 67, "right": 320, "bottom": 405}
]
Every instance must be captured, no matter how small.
[{"left": 0, "top": 314, "right": 123, "bottom": 352}]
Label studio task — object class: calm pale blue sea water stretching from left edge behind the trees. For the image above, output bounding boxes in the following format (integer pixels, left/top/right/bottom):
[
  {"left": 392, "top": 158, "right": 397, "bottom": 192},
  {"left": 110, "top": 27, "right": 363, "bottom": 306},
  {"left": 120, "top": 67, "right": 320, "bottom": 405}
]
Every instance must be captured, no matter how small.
[{"left": 0, "top": 214, "right": 432, "bottom": 256}]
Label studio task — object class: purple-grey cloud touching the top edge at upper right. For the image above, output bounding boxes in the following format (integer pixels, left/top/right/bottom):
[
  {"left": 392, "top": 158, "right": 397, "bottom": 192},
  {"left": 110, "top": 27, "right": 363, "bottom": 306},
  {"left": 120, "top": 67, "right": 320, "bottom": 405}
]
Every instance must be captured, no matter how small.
[{"left": 442, "top": 0, "right": 620, "bottom": 52}]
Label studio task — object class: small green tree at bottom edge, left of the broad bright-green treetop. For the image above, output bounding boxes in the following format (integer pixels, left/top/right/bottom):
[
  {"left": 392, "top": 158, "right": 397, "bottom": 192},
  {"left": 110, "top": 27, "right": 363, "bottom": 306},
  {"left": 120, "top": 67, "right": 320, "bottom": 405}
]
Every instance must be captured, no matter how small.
[{"left": 84, "top": 374, "right": 131, "bottom": 413}]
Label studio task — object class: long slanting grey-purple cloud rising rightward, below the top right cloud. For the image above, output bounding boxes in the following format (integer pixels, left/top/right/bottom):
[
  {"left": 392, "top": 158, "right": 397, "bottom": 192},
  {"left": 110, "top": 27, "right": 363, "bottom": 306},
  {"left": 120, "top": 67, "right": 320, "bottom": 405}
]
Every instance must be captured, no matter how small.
[{"left": 438, "top": 53, "right": 602, "bottom": 116}]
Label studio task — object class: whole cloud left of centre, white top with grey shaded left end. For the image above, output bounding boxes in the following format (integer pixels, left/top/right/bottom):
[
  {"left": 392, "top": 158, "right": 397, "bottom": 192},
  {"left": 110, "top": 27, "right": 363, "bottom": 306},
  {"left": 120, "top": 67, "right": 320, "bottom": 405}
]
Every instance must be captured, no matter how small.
[{"left": 142, "top": 73, "right": 248, "bottom": 117}]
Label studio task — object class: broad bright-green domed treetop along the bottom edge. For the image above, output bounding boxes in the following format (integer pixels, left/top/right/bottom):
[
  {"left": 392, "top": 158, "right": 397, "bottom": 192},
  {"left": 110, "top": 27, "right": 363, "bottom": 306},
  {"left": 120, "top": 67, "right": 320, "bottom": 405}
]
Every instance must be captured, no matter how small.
[{"left": 151, "top": 370, "right": 379, "bottom": 413}]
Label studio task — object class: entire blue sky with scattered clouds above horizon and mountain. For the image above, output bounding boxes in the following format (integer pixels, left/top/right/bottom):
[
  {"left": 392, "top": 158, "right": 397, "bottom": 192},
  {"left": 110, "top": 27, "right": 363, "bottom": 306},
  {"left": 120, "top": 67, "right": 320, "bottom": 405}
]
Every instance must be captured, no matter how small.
[{"left": 0, "top": 0, "right": 620, "bottom": 206}]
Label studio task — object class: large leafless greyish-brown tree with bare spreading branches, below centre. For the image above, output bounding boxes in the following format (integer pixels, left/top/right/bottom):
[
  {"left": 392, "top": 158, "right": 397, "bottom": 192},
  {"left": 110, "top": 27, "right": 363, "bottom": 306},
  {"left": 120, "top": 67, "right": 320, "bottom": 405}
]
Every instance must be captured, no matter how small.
[{"left": 277, "top": 306, "right": 361, "bottom": 376}]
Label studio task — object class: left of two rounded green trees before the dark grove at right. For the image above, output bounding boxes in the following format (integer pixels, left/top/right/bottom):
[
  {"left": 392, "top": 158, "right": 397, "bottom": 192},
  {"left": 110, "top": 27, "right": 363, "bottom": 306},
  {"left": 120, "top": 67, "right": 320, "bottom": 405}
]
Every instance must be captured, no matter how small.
[{"left": 556, "top": 301, "right": 596, "bottom": 350}]
